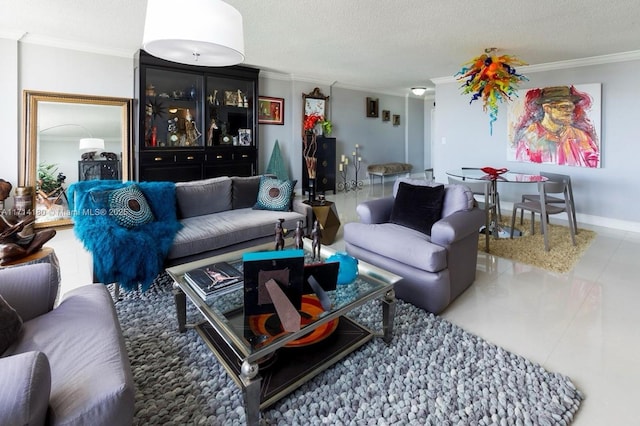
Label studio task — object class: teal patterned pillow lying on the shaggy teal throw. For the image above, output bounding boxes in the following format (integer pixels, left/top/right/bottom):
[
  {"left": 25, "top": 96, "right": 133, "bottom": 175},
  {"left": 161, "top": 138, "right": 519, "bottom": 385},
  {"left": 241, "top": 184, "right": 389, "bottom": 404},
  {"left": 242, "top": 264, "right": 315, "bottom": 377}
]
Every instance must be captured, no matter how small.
[{"left": 108, "top": 185, "right": 155, "bottom": 229}]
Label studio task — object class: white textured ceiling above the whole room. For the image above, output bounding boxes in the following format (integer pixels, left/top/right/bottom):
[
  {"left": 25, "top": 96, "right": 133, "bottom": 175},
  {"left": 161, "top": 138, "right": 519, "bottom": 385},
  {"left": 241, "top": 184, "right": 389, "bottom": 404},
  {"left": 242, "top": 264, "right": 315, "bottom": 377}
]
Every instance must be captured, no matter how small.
[{"left": 0, "top": 0, "right": 640, "bottom": 93}]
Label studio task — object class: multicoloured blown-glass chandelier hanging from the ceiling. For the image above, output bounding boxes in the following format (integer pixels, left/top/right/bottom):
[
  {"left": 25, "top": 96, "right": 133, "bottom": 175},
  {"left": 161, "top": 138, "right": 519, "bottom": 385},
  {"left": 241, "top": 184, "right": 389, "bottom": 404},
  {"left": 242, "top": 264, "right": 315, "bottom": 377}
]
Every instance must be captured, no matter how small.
[{"left": 455, "top": 47, "right": 528, "bottom": 134}]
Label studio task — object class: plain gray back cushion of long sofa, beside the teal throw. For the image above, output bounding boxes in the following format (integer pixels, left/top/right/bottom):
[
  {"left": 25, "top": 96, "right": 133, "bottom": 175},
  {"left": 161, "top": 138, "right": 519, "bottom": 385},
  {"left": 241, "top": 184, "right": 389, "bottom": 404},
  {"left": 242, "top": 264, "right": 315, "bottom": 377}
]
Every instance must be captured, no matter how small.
[{"left": 176, "top": 176, "right": 232, "bottom": 218}]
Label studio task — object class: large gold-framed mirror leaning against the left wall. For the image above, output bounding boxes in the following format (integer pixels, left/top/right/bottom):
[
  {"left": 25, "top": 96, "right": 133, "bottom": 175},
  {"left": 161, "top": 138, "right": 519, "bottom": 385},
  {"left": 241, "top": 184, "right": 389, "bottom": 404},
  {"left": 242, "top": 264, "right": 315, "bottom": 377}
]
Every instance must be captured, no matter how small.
[{"left": 19, "top": 91, "right": 132, "bottom": 228}]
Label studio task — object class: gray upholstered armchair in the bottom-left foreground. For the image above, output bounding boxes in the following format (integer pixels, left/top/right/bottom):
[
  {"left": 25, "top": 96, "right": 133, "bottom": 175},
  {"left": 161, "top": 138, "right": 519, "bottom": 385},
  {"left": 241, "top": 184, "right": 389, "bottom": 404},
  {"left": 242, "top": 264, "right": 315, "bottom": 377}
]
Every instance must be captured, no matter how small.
[{"left": 0, "top": 263, "right": 134, "bottom": 426}]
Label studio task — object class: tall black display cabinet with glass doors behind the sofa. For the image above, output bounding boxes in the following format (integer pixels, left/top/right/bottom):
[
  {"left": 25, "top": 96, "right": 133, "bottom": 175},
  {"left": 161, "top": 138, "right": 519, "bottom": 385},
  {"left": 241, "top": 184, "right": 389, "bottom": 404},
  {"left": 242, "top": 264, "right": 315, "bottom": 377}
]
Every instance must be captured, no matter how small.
[{"left": 134, "top": 50, "right": 260, "bottom": 182}]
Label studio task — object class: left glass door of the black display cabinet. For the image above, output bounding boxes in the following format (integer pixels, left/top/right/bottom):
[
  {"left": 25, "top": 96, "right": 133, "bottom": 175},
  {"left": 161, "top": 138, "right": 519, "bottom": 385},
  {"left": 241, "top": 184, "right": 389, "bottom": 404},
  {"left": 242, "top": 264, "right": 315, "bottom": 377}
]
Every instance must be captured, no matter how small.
[{"left": 144, "top": 68, "right": 206, "bottom": 149}]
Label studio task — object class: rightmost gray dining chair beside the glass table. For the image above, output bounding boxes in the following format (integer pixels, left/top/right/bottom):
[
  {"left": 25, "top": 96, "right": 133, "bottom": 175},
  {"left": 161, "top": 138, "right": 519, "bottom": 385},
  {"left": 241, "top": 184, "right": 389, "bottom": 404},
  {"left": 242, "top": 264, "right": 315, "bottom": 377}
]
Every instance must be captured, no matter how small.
[{"left": 509, "top": 181, "right": 576, "bottom": 251}]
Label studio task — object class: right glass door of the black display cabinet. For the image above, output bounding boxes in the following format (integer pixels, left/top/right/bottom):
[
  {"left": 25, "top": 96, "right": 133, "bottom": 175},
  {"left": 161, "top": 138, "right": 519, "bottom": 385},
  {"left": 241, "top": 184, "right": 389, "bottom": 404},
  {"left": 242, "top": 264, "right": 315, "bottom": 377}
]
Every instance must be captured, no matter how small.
[{"left": 204, "top": 76, "right": 255, "bottom": 146}]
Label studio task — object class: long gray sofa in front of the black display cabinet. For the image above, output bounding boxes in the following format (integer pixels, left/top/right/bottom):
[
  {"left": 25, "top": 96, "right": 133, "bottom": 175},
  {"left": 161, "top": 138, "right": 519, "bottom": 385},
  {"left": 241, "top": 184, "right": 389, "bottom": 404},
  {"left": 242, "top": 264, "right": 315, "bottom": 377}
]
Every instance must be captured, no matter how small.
[{"left": 166, "top": 176, "right": 313, "bottom": 265}]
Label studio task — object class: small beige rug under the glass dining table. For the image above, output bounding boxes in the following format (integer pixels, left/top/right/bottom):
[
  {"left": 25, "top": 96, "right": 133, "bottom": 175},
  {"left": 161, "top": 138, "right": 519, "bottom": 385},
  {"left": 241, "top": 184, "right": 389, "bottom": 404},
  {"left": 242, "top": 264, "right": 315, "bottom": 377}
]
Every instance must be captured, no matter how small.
[{"left": 478, "top": 215, "right": 596, "bottom": 273}]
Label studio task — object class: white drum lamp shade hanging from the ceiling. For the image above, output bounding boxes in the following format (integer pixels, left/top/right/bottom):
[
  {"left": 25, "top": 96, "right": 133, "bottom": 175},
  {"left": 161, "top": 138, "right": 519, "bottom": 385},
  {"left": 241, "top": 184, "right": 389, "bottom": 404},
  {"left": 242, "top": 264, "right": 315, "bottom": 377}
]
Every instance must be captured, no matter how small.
[{"left": 142, "top": 0, "right": 244, "bottom": 67}]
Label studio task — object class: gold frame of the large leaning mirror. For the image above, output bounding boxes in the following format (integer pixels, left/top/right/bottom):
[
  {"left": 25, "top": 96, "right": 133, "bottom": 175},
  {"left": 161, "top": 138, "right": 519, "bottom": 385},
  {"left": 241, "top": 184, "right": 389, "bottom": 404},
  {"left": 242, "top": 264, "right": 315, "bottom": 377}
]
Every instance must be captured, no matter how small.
[{"left": 18, "top": 90, "right": 133, "bottom": 228}]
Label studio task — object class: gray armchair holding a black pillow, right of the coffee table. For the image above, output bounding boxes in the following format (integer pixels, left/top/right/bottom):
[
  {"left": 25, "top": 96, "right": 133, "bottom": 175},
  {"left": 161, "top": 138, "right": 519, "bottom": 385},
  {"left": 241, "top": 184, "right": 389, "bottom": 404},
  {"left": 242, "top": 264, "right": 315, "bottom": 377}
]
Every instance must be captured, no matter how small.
[{"left": 344, "top": 179, "right": 485, "bottom": 314}]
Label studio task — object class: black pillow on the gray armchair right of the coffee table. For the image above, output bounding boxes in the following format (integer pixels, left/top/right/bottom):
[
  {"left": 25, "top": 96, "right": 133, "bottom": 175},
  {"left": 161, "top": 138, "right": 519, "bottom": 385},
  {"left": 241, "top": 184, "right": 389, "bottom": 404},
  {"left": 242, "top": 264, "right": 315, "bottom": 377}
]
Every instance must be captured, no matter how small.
[{"left": 390, "top": 182, "right": 444, "bottom": 235}]
